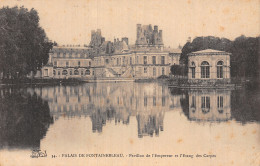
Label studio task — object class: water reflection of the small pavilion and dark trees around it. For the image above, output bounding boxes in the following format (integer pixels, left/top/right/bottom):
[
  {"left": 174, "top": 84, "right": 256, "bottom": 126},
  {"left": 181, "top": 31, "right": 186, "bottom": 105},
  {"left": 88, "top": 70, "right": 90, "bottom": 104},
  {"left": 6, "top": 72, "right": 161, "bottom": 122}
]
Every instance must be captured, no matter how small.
[{"left": 179, "top": 89, "right": 260, "bottom": 124}]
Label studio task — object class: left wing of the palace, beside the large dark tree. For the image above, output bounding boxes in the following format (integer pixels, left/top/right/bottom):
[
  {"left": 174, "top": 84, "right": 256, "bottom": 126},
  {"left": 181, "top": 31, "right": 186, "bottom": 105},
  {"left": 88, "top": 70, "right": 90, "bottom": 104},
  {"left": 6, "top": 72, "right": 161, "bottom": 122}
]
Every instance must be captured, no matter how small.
[{"left": 42, "top": 47, "right": 93, "bottom": 78}]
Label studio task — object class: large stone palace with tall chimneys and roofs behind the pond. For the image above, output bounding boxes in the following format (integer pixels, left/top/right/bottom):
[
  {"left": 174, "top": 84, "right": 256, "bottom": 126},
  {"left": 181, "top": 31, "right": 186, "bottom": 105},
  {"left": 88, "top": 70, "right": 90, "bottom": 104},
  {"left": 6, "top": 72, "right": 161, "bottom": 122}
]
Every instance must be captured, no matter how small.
[{"left": 42, "top": 24, "right": 181, "bottom": 80}]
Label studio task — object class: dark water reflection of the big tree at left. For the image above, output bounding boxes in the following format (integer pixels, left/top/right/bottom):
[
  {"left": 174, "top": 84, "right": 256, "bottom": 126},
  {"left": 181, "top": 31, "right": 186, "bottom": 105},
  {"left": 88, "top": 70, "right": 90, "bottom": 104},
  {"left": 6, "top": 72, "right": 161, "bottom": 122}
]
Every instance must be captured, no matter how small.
[{"left": 0, "top": 88, "right": 53, "bottom": 149}]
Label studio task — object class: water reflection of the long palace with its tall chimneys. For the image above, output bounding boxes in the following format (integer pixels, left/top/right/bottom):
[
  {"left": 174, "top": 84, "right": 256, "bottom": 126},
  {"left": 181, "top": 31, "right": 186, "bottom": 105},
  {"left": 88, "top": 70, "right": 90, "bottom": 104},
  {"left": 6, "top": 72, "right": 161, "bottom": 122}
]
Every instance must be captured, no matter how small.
[{"left": 28, "top": 82, "right": 180, "bottom": 137}]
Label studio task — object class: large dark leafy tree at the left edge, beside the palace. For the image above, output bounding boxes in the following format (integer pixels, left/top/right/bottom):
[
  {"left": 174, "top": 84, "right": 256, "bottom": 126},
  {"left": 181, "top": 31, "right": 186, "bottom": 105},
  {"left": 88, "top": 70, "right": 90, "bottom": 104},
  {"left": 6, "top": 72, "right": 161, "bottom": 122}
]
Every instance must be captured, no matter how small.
[{"left": 0, "top": 7, "right": 53, "bottom": 78}]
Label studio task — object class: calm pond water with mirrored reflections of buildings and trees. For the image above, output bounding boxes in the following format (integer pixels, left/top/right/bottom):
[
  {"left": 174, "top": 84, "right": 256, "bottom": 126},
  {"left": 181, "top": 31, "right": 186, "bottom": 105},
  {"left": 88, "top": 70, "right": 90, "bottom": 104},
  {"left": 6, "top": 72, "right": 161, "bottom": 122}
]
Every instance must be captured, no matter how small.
[{"left": 0, "top": 82, "right": 260, "bottom": 166}]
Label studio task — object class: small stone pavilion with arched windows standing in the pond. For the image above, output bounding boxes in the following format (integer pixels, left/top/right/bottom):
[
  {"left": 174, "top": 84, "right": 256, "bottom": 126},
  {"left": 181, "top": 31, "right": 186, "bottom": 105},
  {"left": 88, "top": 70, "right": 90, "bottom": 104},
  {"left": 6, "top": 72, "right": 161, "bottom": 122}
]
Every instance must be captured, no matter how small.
[{"left": 188, "top": 49, "right": 230, "bottom": 83}]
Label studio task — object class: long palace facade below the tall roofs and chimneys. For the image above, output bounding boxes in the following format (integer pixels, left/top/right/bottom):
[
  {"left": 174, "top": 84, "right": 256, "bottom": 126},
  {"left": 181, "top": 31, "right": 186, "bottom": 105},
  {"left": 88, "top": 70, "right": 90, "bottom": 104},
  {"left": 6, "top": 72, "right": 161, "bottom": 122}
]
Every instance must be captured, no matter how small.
[{"left": 42, "top": 47, "right": 179, "bottom": 79}]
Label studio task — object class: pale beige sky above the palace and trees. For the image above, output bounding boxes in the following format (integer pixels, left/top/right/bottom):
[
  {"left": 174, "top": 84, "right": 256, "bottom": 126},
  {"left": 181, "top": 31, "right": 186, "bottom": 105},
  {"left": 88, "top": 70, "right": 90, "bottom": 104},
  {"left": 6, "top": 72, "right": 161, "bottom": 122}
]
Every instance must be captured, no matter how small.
[{"left": 0, "top": 0, "right": 260, "bottom": 48}]
